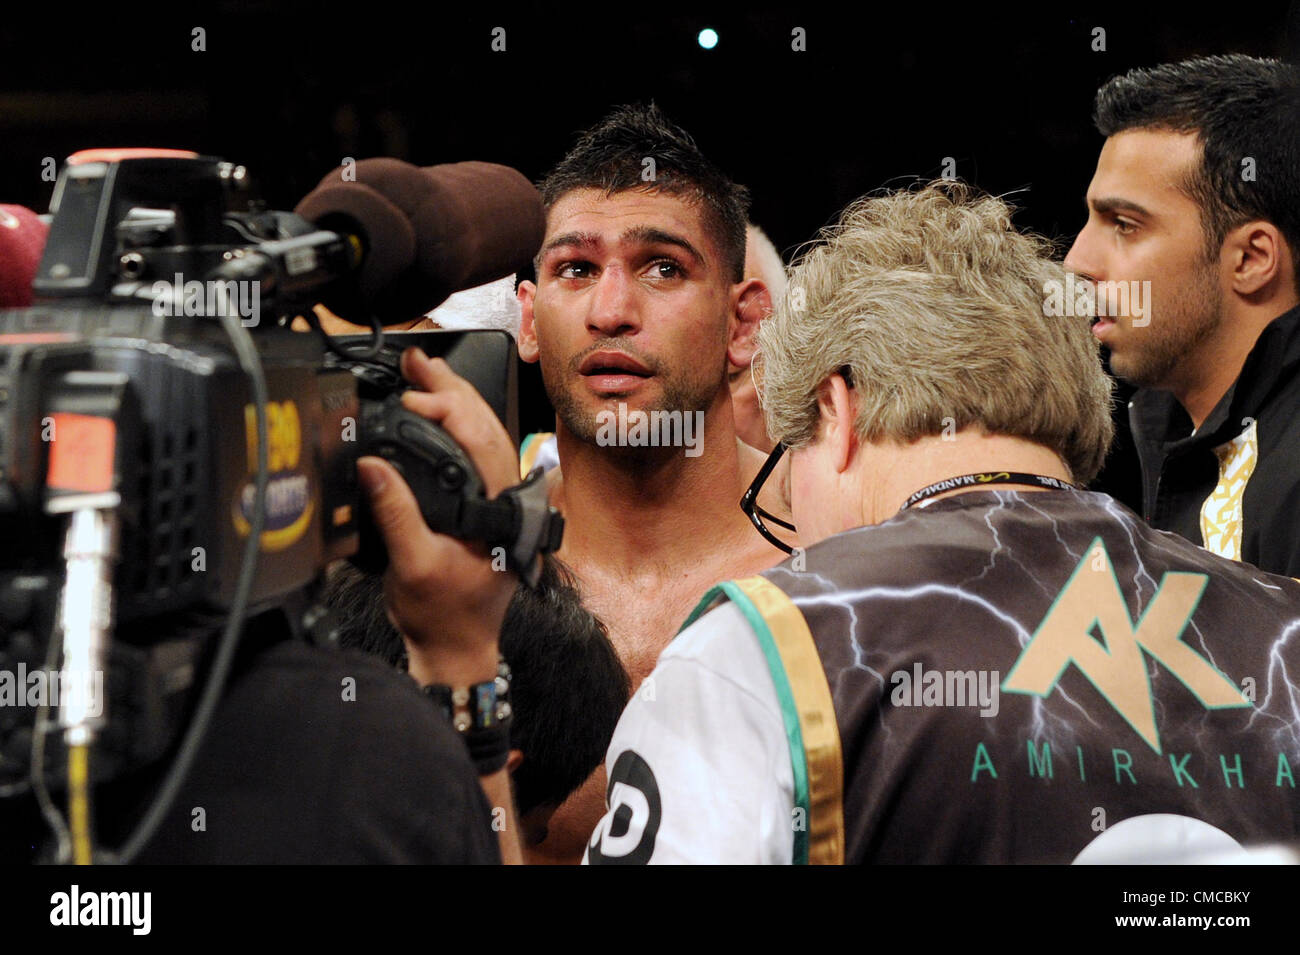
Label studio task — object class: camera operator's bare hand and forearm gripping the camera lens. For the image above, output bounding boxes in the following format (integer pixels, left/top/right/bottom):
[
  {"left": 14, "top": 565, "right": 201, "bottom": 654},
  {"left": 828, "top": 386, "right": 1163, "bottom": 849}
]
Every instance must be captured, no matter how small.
[{"left": 358, "top": 348, "right": 523, "bottom": 863}]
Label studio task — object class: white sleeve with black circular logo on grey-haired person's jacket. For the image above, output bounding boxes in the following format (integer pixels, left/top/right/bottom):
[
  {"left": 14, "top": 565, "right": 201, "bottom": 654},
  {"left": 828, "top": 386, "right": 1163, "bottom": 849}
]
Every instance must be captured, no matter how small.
[{"left": 582, "top": 602, "right": 794, "bottom": 865}]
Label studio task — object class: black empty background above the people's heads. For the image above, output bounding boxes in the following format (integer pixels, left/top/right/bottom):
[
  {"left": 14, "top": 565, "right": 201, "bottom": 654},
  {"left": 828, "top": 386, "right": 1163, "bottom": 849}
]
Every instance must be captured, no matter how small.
[{"left": 0, "top": 0, "right": 1300, "bottom": 511}]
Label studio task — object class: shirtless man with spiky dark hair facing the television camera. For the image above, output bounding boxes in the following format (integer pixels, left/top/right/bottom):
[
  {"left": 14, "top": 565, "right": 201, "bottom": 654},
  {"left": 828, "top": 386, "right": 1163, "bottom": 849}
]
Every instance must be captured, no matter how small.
[{"left": 519, "top": 107, "right": 780, "bottom": 861}]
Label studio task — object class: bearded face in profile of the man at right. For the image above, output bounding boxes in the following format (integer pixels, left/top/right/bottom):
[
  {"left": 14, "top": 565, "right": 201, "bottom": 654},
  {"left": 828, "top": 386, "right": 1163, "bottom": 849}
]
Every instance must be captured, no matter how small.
[{"left": 1065, "top": 130, "right": 1223, "bottom": 388}]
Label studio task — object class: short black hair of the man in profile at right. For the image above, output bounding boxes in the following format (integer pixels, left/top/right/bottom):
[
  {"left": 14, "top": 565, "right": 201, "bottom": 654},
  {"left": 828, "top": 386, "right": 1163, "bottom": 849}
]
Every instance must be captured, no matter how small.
[{"left": 1092, "top": 53, "right": 1300, "bottom": 272}]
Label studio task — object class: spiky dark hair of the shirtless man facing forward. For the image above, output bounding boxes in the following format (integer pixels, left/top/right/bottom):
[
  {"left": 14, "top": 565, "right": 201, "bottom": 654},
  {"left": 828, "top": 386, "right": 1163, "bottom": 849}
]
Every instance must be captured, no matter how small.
[{"left": 537, "top": 103, "right": 749, "bottom": 282}]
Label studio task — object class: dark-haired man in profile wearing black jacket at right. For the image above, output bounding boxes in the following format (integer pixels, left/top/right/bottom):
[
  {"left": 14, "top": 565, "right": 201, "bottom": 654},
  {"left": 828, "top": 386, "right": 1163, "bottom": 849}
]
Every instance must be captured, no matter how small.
[{"left": 1066, "top": 55, "right": 1300, "bottom": 577}]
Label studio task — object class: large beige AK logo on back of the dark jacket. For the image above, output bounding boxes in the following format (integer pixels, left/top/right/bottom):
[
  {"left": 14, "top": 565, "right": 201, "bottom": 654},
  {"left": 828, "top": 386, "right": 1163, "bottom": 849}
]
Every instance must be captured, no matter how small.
[{"left": 1002, "top": 537, "right": 1251, "bottom": 752}]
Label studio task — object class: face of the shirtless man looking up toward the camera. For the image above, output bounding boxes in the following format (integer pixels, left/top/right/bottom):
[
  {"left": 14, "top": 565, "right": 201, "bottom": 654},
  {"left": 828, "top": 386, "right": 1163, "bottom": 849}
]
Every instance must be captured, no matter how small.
[{"left": 519, "top": 188, "right": 751, "bottom": 442}]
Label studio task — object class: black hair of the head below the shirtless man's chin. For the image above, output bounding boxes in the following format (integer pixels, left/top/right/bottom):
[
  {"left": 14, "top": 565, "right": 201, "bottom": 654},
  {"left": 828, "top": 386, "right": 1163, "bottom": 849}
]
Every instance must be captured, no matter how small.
[{"left": 325, "top": 557, "right": 632, "bottom": 816}]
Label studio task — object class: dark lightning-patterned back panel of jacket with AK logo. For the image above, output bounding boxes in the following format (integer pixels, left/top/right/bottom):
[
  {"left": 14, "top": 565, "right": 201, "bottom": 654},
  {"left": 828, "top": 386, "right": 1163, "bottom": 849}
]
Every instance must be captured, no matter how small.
[{"left": 764, "top": 490, "right": 1300, "bottom": 863}]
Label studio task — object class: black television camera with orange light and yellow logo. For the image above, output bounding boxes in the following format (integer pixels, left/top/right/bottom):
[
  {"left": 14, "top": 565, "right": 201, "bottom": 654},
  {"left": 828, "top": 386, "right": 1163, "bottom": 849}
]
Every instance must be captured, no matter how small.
[{"left": 0, "top": 152, "right": 563, "bottom": 860}]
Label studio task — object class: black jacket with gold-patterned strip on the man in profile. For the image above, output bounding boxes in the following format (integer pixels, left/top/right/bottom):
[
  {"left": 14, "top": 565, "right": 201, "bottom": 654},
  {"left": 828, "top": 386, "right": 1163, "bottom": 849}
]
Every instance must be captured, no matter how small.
[{"left": 1128, "top": 307, "right": 1300, "bottom": 577}]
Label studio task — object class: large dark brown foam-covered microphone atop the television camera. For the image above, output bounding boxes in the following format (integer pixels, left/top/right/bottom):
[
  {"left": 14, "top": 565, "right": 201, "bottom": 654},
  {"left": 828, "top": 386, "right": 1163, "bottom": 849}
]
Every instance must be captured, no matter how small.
[{"left": 294, "top": 159, "right": 546, "bottom": 325}]
